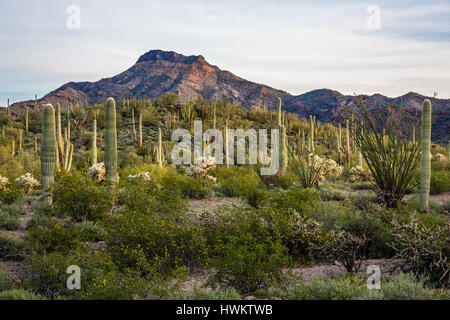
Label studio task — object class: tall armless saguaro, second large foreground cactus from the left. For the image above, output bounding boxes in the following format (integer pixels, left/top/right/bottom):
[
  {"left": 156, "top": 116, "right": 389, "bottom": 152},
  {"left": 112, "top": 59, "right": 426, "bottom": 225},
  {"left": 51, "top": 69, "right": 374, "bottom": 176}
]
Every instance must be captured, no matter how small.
[{"left": 105, "top": 98, "right": 118, "bottom": 184}]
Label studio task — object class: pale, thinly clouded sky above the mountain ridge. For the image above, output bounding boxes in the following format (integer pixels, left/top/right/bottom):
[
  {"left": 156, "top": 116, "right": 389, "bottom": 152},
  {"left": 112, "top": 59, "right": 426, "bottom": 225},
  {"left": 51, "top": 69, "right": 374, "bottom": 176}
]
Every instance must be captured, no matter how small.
[{"left": 0, "top": 0, "right": 450, "bottom": 106}]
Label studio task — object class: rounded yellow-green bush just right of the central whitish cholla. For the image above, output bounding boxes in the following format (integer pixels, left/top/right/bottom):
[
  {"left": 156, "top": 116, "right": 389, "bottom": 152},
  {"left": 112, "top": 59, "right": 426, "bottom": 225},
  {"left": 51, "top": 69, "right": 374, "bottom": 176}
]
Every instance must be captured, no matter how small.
[{"left": 210, "top": 166, "right": 261, "bottom": 197}]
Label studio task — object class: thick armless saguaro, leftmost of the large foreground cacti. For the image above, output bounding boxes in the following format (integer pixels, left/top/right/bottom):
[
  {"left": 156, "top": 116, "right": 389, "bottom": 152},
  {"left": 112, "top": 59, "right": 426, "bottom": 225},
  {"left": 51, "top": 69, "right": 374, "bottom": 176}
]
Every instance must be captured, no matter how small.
[{"left": 41, "top": 104, "right": 56, "bottom": 202}]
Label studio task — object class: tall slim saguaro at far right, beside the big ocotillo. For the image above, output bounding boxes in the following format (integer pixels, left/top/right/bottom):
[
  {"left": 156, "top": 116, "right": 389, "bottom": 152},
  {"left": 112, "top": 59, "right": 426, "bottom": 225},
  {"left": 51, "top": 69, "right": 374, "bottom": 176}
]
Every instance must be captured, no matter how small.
[{"left": 420, "top": 99, "right": 431, "bottom": 211}]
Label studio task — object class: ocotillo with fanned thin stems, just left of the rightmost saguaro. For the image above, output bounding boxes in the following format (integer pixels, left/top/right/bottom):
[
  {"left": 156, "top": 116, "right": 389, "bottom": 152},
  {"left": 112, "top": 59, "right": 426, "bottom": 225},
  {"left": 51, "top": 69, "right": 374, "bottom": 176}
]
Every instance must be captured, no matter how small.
[{"left": 345, "top": 100, "right": 420, "bottom": 208}]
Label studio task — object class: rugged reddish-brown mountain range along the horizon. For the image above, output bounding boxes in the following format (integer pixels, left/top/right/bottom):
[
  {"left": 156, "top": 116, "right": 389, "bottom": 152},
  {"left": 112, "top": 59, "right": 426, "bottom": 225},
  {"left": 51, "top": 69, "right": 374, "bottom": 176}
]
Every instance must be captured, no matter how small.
[{"left": 7, "top": 50, "right": 450, "bottom": 142}]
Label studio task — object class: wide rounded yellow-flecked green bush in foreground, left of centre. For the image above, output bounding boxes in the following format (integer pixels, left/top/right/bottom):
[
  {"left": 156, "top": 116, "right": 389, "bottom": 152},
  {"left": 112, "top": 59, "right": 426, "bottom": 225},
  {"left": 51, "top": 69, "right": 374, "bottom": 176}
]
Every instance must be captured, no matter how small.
[{"left": 107, "top": 211, "right": 207, "bottom": 275}]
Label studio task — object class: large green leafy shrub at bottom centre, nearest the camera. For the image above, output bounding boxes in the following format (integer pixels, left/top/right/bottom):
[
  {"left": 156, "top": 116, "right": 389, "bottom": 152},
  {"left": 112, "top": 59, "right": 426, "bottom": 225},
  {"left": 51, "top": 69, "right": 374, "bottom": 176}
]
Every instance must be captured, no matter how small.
[{"left": 201, "top": 208, "right": 289, "bottom": 294}]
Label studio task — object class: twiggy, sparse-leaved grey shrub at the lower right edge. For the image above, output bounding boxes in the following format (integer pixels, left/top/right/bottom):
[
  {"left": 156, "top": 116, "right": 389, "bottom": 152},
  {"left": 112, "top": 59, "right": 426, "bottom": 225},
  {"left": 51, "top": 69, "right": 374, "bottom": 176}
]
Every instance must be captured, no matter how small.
[{"left": 392, "top": 216, "right": 450, "bottom": 286}]
